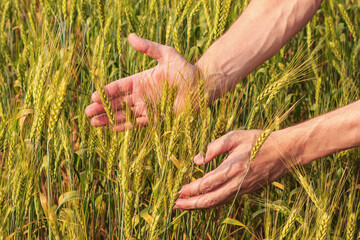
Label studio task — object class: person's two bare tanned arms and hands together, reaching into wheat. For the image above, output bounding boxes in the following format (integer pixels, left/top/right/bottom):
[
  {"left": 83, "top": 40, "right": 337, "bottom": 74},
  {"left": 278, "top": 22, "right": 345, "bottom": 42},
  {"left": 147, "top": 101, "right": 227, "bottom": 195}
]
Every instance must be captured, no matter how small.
[{"left": 85, "top": 0, "right": 360, "bottom": 209}]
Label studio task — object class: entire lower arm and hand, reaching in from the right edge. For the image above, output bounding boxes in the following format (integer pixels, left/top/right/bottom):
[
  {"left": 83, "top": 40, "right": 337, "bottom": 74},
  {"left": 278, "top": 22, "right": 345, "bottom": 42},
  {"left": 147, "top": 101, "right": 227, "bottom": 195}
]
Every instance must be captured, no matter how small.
[{"left": 175, "top": 100, "right": 360, "bottom": 209}]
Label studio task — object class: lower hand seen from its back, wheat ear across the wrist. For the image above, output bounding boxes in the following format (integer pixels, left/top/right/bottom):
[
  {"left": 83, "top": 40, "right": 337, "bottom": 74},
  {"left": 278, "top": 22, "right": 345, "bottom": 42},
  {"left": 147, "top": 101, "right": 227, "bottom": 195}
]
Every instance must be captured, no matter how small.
[{"left": 174, "top": 130, "right": 288, "bottom": 209}]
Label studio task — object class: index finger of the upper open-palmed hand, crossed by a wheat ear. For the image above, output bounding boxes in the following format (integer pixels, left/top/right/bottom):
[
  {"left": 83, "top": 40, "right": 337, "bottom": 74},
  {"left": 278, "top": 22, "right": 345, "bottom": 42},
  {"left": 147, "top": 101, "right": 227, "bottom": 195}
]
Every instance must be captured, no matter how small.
[{"left": 91, "top": 73, "right": 142, "bottom": 102}]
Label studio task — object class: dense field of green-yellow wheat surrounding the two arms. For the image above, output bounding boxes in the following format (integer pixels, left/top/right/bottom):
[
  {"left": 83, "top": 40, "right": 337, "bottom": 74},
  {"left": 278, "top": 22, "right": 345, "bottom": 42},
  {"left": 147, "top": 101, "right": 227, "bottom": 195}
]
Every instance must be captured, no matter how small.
[{"left": 0, "top": 0, "right": 360, "bottom": 239}]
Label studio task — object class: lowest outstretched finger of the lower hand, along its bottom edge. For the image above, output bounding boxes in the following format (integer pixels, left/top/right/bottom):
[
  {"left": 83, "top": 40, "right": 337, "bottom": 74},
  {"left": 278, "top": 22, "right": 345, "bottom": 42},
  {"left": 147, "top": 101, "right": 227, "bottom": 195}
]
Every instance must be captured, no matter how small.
[{"left": 174, "top": 181, "right": 235, "bottom": 209}]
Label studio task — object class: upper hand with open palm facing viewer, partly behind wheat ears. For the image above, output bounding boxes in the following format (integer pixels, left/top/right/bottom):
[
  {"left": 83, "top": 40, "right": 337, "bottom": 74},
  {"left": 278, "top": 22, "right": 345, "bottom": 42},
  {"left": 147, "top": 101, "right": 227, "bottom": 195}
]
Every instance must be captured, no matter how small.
[{"left": 85, "top": 33, "right": 197, "bottom": 131}]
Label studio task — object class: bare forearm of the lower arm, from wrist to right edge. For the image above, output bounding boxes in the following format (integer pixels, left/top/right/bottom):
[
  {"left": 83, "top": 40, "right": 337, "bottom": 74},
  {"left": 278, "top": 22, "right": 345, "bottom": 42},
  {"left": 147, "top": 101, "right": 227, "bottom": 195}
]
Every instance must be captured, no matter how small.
[{"left": 277, "top": 100, "right": 360, "bottom": 165}]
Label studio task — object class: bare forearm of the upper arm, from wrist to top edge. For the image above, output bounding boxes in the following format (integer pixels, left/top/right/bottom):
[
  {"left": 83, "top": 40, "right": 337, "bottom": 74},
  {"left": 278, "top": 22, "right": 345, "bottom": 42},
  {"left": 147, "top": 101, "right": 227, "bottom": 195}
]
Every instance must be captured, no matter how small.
[{"left": 196, "top": 0, "right": 321, "bottom": 98}]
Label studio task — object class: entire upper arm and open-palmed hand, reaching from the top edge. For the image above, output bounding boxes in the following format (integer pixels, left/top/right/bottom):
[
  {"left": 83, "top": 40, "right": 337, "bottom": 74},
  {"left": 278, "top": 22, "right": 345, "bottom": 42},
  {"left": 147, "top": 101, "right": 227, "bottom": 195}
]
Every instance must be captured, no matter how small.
[{"left": 85, "top": 0, "right": 321, "bottom": 131}]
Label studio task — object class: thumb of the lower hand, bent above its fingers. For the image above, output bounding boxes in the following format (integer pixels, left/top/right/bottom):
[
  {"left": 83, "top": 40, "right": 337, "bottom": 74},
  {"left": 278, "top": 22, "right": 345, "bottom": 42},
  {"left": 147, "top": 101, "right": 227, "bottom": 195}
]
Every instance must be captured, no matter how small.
[{"left": 194, "top": 132, "right": 235, "bottom": 165}]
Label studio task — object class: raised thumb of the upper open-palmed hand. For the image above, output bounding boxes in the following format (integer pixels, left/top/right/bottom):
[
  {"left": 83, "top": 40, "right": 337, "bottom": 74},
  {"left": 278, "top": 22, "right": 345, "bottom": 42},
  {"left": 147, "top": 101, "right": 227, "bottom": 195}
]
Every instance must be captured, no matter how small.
[{"left": 128, "top": 33, "right": 168, "bottom": 61}]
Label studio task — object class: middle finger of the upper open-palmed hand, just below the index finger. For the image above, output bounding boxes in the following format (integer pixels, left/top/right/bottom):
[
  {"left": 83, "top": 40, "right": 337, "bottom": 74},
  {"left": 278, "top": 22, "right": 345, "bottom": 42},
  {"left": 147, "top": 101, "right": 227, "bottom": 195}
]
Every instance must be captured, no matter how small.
[{"left": 85, "top": 94, "right": 138, "bottom": 117}]
